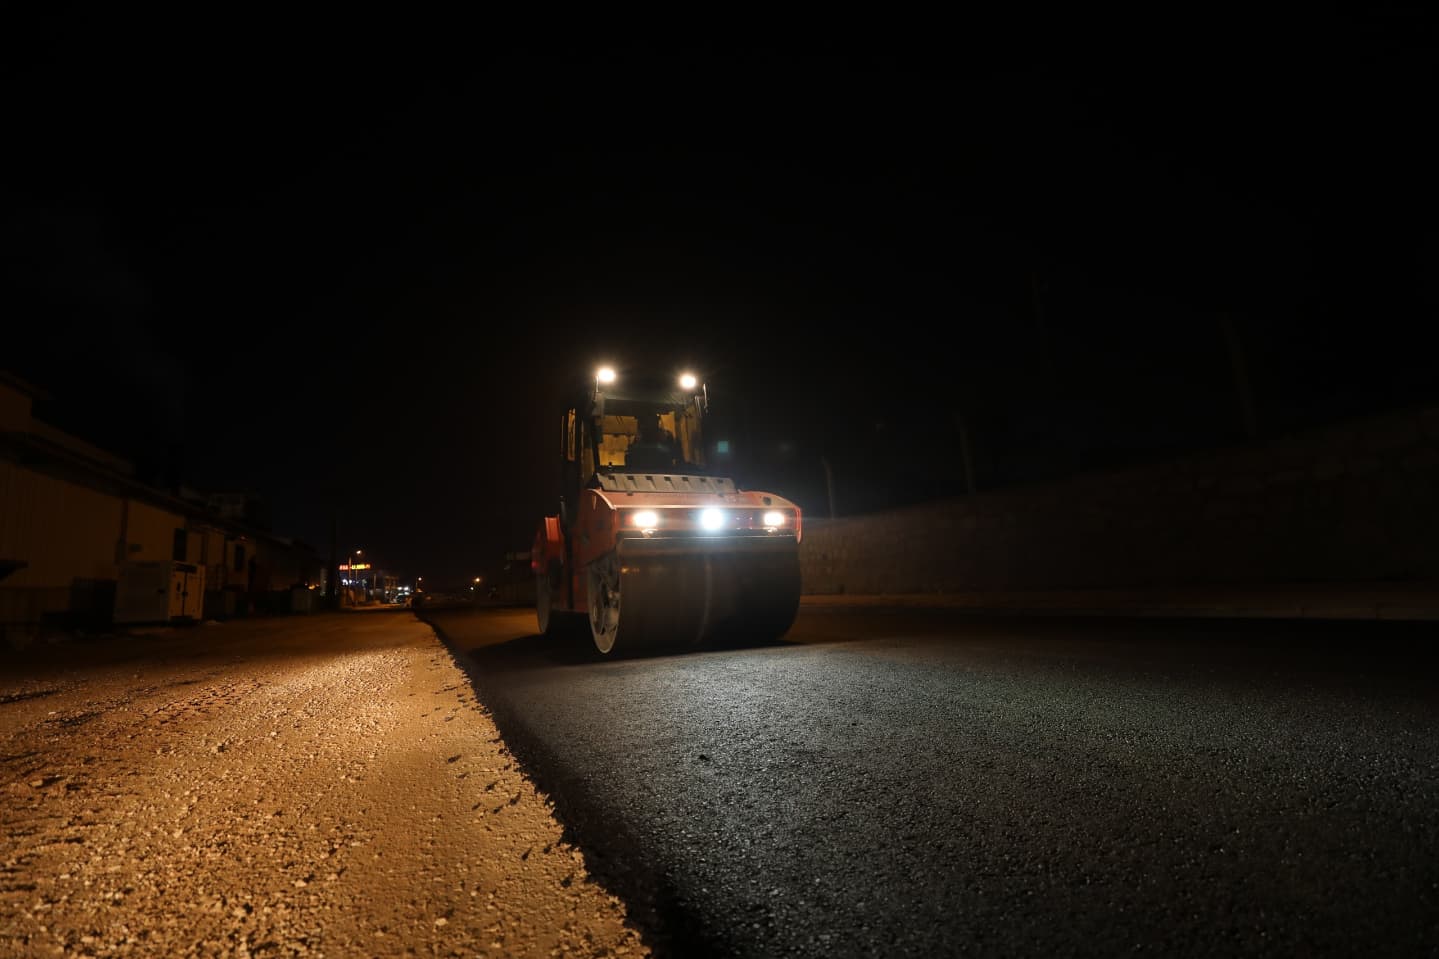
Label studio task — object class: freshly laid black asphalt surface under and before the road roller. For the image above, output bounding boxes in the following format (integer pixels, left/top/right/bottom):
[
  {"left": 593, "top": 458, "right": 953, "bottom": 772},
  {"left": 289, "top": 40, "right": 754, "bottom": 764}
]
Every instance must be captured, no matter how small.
[{"left": 422, "top": 608, "right": 1439, "bottom": 958}]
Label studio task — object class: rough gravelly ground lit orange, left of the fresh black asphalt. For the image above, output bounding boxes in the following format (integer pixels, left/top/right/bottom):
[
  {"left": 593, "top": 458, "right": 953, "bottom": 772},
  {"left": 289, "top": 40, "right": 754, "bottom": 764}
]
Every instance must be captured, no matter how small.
[{"left": 0, "top": 612, "right": 648, "bottom": 958}]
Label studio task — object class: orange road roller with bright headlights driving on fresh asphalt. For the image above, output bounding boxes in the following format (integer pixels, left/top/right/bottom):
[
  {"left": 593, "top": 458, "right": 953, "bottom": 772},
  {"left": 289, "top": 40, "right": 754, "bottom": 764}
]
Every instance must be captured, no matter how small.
[{"left": 531, "top": 367, "right": 802, "bottom": 655}]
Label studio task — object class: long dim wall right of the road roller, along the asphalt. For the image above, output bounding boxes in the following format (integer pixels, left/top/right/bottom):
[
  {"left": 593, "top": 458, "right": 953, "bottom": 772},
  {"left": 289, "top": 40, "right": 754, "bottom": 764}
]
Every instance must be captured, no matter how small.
[{"left": 802, "top": 409, "right": 1439, "bottom": 593}]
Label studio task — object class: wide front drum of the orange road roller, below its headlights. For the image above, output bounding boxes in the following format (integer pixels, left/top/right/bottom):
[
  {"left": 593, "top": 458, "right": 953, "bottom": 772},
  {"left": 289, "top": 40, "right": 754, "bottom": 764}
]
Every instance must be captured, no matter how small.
[{"left": 586, "top": 547, "right": 800, "bottom": 654}]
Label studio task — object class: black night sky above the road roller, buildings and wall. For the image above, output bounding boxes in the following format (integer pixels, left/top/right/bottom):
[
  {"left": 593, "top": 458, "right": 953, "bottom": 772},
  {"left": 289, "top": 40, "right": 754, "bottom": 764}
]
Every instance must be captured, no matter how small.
[{"left": 0, "top": 14, "right": 1439, "bottom": 577}]
